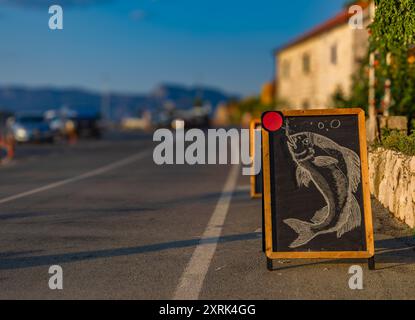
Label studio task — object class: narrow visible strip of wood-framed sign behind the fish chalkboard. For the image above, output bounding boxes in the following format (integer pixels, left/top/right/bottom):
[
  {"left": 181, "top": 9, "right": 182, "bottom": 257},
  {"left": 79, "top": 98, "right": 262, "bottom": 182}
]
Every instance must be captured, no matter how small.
[{"left": 249, "top": 119, "right": 262, "bottom": 198}]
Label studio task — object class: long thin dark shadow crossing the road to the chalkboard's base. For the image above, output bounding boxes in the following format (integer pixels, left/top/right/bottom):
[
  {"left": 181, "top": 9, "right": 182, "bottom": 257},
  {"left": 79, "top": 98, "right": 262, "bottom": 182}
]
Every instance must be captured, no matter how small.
[{"left": 0, "top": 232, "right": 261, "bottom": 270}]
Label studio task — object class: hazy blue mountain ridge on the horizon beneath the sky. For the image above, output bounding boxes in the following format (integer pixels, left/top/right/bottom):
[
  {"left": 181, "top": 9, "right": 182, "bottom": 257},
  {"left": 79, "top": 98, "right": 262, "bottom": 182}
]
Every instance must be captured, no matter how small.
[{"left": 0, "top": 84, "right": 236, "bottom": 119}]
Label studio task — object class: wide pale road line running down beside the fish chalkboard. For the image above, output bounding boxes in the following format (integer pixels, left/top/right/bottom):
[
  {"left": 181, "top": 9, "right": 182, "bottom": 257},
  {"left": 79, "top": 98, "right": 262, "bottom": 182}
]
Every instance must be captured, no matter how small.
[{"left": 173, "top": 165, "right": 240, "bottom": 300}]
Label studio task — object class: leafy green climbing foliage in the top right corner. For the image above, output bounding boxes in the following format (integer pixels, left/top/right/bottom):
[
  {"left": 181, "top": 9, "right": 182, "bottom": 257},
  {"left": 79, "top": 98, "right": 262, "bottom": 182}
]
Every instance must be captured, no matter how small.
[{"left": 370, "top": 0, "right": 415, "bottom": 127}]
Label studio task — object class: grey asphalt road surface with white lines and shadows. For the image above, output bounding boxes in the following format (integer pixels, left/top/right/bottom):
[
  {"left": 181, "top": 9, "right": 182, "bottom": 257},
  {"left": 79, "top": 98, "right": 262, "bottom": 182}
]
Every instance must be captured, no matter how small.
[{"left": 0, "top": 134, "right": 415, "bottom": 299}]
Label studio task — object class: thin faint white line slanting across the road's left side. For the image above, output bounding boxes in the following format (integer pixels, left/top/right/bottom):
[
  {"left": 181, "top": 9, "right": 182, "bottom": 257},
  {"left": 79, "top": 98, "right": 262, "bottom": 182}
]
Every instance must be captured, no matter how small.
[{"left": 0, "top": 150, "right": 150, "bottom": 204}]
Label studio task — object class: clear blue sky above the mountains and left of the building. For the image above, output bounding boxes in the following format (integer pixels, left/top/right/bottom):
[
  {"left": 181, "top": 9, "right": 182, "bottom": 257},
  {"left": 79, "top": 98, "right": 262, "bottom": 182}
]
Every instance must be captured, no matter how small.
[{"left": 0, "top": 0, "right": 345, "bottom": 95}]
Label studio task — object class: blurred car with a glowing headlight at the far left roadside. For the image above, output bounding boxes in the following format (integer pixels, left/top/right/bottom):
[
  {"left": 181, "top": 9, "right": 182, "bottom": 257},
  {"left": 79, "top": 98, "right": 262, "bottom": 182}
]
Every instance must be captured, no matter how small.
[{"left": 7, "top": 114, "right": 54, "bottom": 143}]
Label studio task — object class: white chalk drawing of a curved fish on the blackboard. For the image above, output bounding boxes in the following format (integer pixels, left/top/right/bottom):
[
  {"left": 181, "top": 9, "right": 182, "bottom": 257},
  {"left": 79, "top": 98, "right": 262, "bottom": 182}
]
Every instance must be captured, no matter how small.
[{"left": 284, "top": 129, "right": 362, "bottom": 248}]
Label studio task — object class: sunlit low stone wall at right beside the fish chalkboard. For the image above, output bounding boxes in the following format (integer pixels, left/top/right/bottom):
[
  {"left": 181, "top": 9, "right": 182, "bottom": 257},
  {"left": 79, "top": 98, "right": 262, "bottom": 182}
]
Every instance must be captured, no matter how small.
[{"left": 369, "top": 148, "right": 415, "bottom": 228}]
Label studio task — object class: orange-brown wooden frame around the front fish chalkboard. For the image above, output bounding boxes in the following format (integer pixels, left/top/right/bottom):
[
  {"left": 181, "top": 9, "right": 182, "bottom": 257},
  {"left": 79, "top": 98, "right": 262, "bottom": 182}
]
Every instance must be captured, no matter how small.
[{"left": 262, "top": 108, "right": 375, "bottom": 259}]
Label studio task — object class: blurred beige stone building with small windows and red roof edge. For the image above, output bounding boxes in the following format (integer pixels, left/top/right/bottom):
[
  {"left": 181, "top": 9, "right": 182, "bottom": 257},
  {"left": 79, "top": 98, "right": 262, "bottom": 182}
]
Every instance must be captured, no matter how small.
[{"left": 275, "top": 2, "right": 370, "bottom": 109}]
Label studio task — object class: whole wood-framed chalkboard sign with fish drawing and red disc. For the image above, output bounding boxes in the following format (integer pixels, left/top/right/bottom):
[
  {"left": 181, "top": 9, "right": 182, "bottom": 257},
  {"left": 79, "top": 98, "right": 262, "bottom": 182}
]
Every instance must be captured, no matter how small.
[{"left": 262, "top": 109, "right": 374, "bottom": 268}]
